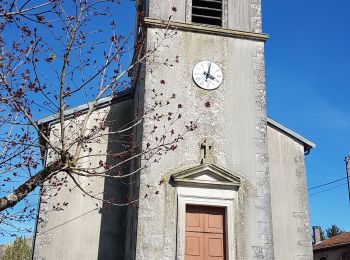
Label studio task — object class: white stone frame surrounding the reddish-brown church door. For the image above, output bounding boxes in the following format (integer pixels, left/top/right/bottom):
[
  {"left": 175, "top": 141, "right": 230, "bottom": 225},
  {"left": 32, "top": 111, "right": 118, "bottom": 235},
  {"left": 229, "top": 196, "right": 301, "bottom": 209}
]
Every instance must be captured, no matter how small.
[{"left": 176, "top": 187, "right": 237, "bottom": 260}]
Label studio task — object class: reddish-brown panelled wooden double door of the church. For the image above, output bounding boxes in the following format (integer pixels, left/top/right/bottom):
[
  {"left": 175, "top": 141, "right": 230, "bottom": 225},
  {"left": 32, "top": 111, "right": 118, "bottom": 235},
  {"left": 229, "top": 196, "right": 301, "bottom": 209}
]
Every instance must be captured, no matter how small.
[{"left": 185, "top": 205, "right": 226, "bottom": 260}]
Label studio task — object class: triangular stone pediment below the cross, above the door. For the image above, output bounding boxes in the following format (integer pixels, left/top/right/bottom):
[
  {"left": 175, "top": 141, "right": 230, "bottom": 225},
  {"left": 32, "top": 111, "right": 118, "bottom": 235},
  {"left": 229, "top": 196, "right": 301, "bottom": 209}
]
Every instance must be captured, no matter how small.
[{"left": 172, "top": 164, "right": 241, "bottom": 187}]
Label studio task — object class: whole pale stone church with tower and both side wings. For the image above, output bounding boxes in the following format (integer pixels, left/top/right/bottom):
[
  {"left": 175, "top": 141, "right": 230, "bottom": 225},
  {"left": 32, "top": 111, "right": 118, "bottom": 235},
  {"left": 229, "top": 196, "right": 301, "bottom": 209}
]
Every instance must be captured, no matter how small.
[{"left": 34, "top": 0, "right": 315, "bottom": 260}]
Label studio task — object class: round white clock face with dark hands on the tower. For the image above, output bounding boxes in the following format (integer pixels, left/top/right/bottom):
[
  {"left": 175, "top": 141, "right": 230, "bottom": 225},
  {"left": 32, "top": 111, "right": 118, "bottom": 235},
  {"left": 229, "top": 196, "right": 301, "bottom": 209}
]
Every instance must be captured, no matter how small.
[{"left": 192, "top": 61, "right": 223, "bottom": 90}]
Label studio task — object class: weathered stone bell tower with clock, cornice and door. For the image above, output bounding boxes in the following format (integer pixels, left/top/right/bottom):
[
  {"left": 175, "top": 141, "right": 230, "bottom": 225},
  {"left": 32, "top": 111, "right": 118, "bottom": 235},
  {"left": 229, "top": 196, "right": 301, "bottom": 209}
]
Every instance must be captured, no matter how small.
[{"left": 131, "top": 0, "right": 274, "bottom": 260}]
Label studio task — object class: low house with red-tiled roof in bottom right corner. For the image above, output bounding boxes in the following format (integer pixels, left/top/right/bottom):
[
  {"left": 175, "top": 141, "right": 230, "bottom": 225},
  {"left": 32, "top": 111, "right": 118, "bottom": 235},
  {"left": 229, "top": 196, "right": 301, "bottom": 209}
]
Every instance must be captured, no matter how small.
[{"left": 313, "top": 232, "right": 350, "bottom": 260}]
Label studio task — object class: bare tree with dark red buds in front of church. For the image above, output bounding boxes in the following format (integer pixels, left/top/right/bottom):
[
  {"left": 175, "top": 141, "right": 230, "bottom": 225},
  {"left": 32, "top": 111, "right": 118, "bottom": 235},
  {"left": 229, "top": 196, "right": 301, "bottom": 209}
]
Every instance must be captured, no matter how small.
[{"left": 0, "top": 0, "right": 196, "bottom": 238}]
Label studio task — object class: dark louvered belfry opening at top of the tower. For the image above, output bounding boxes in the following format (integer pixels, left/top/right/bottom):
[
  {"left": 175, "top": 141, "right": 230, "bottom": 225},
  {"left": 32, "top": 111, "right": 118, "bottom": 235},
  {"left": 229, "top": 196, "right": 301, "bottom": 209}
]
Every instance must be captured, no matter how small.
[{"left": 192, "top": 0, "right": 223, "bottom": 26}]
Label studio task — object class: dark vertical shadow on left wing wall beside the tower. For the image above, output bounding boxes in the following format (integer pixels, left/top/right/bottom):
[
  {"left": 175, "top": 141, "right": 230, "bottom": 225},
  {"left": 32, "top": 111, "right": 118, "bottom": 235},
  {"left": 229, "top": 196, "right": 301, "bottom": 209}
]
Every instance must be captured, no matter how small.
[{"left": 98, "top": 100, "right": 133, "bottom": 260}]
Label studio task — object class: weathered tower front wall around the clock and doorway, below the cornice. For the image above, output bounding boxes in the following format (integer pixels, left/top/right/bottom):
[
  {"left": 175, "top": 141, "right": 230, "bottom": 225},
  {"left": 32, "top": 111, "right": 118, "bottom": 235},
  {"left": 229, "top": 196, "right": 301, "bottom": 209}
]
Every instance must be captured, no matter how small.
[{"left": 136, "top": 23, "right": 273, "bottom": 260}]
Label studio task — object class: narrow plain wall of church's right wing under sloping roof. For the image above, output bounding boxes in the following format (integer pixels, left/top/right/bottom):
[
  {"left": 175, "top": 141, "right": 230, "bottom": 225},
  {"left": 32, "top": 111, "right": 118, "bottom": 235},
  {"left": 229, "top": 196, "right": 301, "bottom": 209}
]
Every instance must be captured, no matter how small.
[{"left": 268, "top": 127, "right": 312, "bottom": 260}]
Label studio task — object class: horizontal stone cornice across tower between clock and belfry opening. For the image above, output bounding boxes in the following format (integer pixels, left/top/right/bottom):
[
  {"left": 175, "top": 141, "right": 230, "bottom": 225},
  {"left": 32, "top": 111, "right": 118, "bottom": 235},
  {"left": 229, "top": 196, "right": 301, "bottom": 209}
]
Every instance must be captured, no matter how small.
[{"left": 144, "top": 17, "right": 269, "bottom": 42}]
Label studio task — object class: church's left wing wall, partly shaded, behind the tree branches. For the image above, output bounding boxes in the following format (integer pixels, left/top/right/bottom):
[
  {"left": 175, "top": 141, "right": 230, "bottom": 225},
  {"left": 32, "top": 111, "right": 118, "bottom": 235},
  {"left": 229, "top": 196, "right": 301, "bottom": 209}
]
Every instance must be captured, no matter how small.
[{"left": 34, "top": 99, "right": 133, "bottom": 260}]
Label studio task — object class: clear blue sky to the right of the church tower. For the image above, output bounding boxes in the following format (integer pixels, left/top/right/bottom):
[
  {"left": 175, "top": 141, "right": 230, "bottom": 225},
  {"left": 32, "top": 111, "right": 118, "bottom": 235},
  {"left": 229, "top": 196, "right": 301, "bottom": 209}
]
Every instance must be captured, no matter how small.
[{"left": 263, "top": 0, "right": 350, "bottom": 231}]
